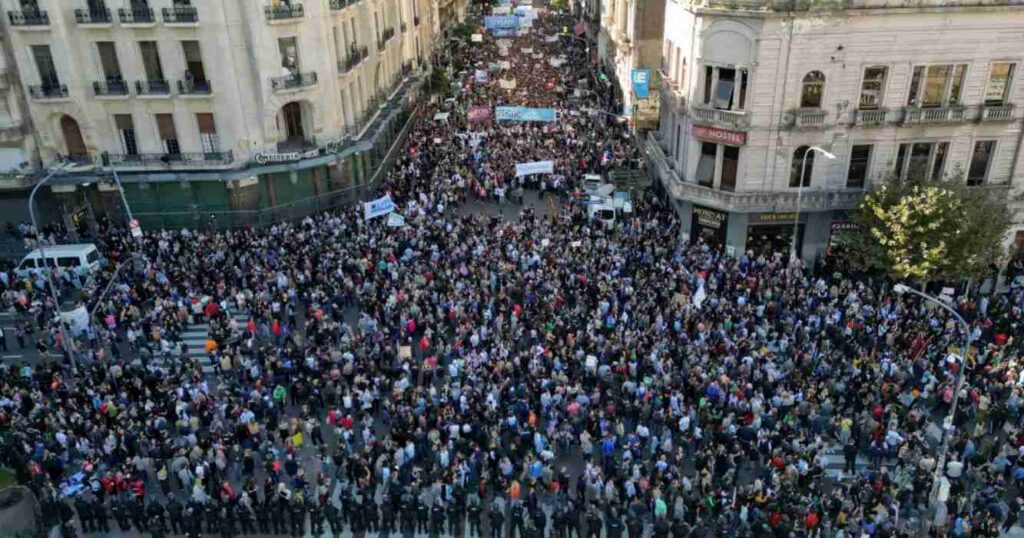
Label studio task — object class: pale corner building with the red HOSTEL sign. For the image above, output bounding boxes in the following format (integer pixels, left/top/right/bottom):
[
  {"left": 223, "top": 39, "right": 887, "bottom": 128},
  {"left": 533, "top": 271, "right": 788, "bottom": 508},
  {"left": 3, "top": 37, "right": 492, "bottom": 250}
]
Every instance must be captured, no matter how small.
[{"left": 647, "top": 0, "right": 1024, "bottom": 260}]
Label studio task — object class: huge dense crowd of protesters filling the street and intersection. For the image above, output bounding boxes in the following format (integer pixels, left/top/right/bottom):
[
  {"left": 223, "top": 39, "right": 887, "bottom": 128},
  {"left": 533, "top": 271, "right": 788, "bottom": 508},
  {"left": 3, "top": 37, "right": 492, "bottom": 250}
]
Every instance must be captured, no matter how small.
[{"left": 0, "top": 4, "right": 1024, "bottom": 537}]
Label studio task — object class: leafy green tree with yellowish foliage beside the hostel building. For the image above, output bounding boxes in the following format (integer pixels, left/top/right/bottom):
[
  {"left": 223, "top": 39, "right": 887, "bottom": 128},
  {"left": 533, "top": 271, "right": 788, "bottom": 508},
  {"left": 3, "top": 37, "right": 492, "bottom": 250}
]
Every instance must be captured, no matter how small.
[{"left": 845, "top": 172, "right": 1010, "bottom": 284}]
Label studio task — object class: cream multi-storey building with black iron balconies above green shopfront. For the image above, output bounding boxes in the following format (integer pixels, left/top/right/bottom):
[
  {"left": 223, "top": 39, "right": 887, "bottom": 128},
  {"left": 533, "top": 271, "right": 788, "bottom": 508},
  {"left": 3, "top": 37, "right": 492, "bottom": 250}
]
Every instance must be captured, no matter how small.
[{"left": 0, "top": 0, "right": 439, "bottom": 225}]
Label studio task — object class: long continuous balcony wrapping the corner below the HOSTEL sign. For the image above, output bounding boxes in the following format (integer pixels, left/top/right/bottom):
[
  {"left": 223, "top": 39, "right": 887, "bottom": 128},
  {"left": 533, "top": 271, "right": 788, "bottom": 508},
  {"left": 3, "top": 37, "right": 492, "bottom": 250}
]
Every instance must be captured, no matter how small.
[{"left": 646, "top": 132, "right": 863, "bottom": 213}]
